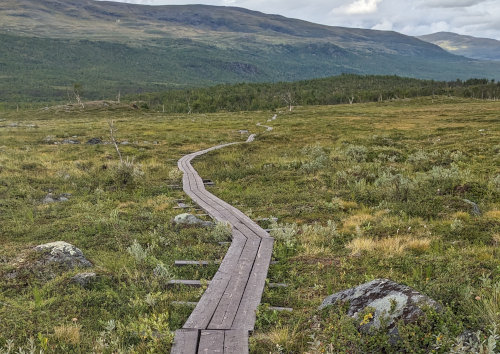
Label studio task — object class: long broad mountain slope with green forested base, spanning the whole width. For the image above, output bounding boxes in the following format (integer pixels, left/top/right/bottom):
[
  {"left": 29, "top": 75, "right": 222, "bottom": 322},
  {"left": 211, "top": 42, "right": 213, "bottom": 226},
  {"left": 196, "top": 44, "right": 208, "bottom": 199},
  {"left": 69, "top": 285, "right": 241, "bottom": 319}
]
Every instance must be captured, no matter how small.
[{"left": 0, "top": 0, "right": 500, "bottom": 101}]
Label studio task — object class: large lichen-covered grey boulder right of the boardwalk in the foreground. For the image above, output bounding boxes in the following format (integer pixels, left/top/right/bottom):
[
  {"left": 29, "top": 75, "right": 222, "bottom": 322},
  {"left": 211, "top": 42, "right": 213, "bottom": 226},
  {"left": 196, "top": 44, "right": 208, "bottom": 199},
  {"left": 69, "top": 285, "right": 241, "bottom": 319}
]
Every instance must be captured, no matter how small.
[{"left": 320, "top": 279, "right": 440, "bottom": 336}]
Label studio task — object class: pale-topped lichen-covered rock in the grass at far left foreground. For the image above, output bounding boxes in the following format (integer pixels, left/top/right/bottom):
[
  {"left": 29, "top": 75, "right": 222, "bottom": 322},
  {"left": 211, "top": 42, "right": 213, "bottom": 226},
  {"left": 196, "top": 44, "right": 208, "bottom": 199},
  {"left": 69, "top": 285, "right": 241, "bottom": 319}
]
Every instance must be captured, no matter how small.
[{"left": 35, "top": 241, "right": 92, "bottom": 268}]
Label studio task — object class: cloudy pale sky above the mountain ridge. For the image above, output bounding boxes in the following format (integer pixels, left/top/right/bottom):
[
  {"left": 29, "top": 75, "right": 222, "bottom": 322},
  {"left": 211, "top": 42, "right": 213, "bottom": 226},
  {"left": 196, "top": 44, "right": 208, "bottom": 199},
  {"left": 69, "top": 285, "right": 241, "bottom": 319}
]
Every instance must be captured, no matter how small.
[{"left": 97, "top": 0, "right": 500, "bottom": 40}]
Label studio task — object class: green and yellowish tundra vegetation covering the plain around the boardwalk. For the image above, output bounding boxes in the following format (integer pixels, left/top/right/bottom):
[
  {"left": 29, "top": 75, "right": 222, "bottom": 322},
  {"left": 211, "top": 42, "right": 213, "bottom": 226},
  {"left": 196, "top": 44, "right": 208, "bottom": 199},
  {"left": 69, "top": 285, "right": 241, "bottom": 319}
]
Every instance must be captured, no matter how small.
[{"left": 0, "top": 96, "right": 500, "bottom": 353}]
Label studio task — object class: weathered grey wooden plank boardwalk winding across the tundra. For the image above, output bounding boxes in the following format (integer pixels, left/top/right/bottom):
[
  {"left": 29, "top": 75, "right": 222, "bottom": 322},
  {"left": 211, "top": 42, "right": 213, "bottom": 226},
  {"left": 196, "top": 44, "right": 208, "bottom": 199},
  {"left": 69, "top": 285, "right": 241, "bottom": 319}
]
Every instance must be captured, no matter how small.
[{"left": 172, "top": 124, "right": 274, "bottom": 354}]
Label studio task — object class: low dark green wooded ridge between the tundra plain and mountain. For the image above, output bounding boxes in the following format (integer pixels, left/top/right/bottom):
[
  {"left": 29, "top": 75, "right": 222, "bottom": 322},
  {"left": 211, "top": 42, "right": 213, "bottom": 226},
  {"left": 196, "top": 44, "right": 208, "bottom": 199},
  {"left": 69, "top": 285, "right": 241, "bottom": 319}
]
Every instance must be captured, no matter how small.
[{"left": 135, "top": 74, "right": 500, "bottom": 113}]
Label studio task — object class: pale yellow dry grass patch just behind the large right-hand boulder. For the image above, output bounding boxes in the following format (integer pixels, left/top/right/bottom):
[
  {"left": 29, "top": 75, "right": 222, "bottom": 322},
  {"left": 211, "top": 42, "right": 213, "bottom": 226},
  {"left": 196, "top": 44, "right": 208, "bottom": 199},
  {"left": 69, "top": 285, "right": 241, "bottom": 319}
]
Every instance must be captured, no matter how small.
[{"left": 346, "top": 236, "right": 431, "bottom": 256}]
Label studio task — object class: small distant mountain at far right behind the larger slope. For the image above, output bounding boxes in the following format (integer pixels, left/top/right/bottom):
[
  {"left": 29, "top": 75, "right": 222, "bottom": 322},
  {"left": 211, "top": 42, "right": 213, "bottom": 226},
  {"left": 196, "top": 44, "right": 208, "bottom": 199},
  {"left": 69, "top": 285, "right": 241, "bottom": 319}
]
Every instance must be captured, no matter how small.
[{"left": 417, "top": 32, "right": 500, "bottom": 60}]
